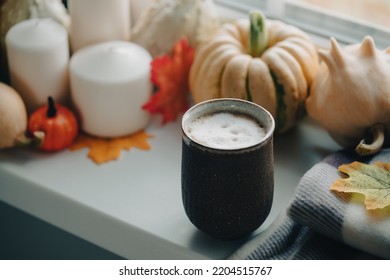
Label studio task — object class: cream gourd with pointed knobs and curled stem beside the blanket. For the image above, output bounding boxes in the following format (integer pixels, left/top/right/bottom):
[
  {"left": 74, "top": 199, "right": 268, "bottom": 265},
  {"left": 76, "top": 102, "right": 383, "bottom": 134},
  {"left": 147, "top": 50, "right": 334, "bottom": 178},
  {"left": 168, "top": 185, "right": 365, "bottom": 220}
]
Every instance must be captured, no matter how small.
[{"left": 306, "top": 36, "right": 390, "bottom": 155}]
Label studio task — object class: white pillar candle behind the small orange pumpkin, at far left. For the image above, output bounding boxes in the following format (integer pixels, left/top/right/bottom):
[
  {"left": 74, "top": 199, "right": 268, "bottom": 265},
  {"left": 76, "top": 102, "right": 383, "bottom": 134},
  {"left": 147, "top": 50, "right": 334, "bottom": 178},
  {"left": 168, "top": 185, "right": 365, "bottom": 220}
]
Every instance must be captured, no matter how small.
[{"left": 5, "top": 18, "right": 69, "bottom": 113}]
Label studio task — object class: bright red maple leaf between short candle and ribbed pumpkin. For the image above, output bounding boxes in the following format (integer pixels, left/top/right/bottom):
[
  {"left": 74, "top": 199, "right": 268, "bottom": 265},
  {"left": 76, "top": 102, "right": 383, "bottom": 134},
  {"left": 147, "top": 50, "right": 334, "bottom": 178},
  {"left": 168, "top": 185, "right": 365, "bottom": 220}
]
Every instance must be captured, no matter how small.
[{"left": 142, "top": 39, "right": 195, "bottom": 124}]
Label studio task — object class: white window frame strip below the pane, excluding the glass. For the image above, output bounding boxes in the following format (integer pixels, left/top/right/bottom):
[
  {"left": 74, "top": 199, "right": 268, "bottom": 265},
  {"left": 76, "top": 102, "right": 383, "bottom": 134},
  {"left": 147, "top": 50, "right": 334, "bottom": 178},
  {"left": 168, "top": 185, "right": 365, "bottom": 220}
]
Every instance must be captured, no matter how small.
[{"left": 214, "top": 0, "right": 390, "bottom": 49}]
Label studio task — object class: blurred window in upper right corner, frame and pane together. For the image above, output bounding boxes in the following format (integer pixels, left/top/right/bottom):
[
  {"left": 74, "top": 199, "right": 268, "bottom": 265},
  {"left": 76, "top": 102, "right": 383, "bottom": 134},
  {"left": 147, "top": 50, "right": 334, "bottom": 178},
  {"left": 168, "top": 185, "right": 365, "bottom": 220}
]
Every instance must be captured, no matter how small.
[{"left": 214, "top": 0, "right": 390, "bottom": 49}]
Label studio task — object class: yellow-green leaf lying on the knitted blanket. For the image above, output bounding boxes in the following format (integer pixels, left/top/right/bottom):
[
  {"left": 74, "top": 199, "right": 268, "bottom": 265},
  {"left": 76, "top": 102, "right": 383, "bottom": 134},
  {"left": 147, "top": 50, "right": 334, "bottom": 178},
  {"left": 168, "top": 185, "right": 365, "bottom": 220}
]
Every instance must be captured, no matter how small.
[{"left": 330, "top": 161, "right": 390, "bottom": 210}]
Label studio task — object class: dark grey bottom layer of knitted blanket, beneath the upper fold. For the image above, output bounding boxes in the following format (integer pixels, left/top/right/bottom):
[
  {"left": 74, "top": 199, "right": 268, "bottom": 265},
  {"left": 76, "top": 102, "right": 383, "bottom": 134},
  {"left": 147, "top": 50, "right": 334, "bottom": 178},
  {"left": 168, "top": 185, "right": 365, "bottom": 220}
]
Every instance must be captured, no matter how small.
[{"left": 229, "top": 212, "right": 378, "bottom": 260}]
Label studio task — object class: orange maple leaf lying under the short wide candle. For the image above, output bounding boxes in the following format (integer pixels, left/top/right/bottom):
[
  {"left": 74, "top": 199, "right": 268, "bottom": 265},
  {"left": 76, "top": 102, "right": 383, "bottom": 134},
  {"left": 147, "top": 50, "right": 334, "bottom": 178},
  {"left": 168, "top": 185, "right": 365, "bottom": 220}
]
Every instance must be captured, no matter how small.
[{"left": 69, "top": 131, "right": 153, "bottom": 164}]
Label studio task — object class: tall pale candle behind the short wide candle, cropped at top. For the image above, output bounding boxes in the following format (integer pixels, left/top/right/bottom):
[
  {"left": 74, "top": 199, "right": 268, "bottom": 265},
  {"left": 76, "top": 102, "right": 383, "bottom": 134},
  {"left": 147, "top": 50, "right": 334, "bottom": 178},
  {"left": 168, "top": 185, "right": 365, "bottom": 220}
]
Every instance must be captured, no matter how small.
[{"left": 69, "top": 0, "right": 131, "bottom": 52}]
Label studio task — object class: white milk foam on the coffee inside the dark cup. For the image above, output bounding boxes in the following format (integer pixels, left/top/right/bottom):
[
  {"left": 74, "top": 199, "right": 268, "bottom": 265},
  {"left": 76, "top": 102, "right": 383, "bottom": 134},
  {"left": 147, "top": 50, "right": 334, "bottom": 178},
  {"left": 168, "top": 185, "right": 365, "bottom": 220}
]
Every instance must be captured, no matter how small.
[{"left": 186, "top": 112, "right": 266, "bottom": 150}]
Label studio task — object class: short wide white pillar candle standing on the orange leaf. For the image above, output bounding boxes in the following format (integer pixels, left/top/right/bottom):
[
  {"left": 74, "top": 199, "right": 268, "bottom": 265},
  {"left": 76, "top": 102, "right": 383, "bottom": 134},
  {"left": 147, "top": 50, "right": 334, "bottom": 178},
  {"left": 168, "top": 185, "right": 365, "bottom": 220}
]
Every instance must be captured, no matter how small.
[{"left": 70, "top": 41, "right": 152, "bottom": 137}]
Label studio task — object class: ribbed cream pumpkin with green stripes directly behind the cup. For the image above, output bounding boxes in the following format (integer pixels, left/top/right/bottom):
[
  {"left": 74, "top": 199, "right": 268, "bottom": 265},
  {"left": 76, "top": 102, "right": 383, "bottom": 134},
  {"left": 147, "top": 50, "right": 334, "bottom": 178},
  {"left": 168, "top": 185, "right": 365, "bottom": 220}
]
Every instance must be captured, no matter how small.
[{"left": 189, "top": 11, "right": 318, "bottom": 132}]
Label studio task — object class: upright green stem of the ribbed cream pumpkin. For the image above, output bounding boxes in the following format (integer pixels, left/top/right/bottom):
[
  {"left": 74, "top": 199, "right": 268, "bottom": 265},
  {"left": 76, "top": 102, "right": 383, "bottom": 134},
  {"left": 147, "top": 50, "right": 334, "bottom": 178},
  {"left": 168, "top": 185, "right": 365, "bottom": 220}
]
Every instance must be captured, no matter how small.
[{"left": 248, "top": 11, "right": 268, "bottom": 57}]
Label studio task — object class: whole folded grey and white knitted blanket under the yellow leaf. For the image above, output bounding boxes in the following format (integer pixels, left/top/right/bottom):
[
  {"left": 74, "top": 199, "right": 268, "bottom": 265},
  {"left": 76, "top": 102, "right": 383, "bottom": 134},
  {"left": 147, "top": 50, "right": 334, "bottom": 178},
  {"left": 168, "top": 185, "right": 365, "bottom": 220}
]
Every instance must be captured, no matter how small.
[{"left": 230, "top": 149, "right": 390, "bottom": 260}]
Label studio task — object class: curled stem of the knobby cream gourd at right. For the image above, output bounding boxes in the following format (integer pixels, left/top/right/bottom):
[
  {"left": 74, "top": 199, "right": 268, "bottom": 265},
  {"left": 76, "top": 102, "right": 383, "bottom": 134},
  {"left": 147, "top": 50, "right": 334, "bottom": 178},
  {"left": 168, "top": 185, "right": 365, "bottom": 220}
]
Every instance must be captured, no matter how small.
[{"left": 355, "top": 123, "right": 385, "bottom": 156}]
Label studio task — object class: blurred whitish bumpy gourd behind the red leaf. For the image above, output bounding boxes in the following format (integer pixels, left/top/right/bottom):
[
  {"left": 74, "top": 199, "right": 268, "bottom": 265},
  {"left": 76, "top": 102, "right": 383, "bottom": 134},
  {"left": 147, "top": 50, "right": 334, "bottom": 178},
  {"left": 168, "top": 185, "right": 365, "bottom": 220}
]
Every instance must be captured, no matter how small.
[{"left": 131, "top": 0, "right": 219, "bottom": 57}]
